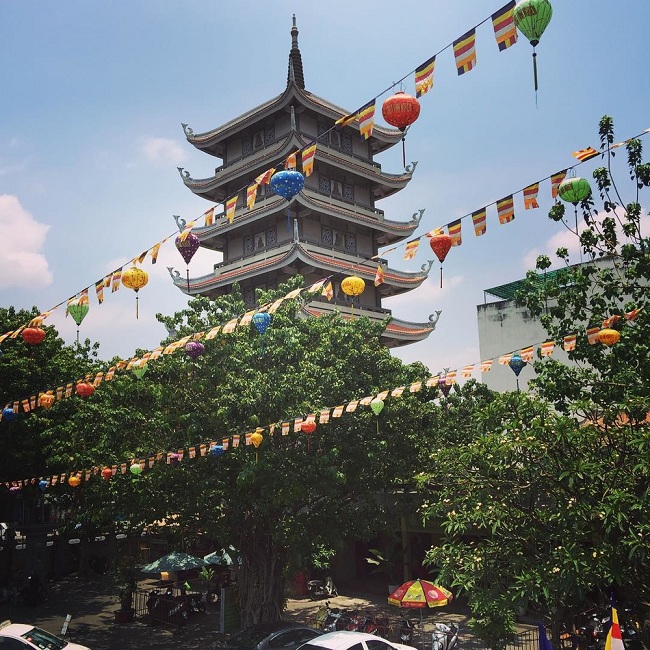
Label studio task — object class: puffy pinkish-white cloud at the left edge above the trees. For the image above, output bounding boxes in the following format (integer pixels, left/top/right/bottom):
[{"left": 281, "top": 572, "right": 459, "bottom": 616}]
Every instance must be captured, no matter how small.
[{"left": 0, "top": 194, "right": 53, "bottom": 289}]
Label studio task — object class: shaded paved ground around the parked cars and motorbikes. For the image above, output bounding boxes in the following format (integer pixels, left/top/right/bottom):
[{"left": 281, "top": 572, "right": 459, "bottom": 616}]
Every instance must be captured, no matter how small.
[{"left": 0, "top": 576, "right": 484, "bottom": 650}]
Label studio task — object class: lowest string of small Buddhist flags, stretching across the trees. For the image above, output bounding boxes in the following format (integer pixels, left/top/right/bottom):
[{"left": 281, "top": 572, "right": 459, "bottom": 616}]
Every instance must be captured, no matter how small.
[{"left": 3, "top": 306, "right": 641, "bottom": 491}]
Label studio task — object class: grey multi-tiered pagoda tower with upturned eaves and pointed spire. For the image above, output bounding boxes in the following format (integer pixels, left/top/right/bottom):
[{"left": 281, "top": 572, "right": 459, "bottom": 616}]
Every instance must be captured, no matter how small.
[{"left": 170, "top": 16, "right": 439, "bottom": 347}]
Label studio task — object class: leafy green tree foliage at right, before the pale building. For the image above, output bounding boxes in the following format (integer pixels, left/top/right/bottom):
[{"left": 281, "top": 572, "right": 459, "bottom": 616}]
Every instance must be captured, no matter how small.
[{"left": 422, "top": 117, "right": 650, "bottom": 648}]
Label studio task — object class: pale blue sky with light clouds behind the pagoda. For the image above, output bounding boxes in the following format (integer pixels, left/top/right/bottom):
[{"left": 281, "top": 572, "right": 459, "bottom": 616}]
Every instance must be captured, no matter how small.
[{"left": 0, "top": 0, "right": 650, "bottom": 373}]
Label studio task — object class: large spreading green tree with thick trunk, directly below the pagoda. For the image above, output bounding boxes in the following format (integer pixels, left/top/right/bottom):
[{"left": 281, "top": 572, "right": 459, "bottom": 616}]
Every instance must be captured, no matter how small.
[{"left": 40, "top": 278, "right": 431, "bottom": 624}]
